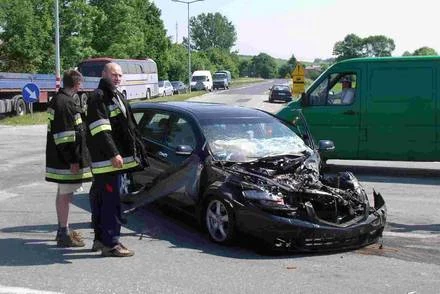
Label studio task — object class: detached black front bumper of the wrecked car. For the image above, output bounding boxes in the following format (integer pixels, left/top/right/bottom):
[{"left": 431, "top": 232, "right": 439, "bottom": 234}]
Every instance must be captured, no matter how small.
[{"left": 236, "top": 196, "right": 387, "bottom": 252}]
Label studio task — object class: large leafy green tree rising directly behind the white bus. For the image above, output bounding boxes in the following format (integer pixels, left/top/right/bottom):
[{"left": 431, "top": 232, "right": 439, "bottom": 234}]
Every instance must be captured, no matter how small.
[{"left": 90, "top": 0, "right": 171, "bottom": 78}]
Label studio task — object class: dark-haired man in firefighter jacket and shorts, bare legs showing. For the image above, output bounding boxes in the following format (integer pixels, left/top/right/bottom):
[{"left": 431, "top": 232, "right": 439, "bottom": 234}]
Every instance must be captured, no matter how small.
[{"left": 46, "top": 70, "right": 92, "bottom": 247}]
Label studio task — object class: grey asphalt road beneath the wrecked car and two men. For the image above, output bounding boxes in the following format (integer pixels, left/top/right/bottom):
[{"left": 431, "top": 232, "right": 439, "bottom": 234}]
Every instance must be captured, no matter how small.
[{"left": 0, "top": 81, "right": 440, "bottom": 294}]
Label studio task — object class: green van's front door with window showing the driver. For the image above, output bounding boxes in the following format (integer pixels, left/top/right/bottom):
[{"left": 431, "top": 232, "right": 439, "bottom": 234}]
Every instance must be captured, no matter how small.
[{"left": 303, "top": 69, "right": 362, "bottom": 159}]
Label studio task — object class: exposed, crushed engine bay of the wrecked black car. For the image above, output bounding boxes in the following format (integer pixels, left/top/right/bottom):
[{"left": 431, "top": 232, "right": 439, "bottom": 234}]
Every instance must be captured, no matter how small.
[{"left": 228, "top": 154, "right": 370, "bottom": 225}]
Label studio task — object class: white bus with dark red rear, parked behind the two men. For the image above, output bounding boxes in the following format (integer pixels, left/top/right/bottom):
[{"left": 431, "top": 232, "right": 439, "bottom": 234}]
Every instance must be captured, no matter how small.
[{"left": 78, "top": 57, "right": 159, "bottom": 100}]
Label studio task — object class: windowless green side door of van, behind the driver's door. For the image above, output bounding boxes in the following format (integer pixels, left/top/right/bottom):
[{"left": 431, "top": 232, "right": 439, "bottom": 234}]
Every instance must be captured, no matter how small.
[{"left": 361, "top": 61, "right": 438, "bottom": 161}]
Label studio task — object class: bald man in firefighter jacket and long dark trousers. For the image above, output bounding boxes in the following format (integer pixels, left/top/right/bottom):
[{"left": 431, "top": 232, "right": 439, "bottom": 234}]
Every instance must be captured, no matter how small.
[{"left": 87, "top": 62, "right": 146, "bottom": 257}]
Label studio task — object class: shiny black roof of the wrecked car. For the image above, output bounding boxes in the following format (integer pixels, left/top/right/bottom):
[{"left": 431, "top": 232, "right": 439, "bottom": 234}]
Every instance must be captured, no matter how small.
[{"left": 132, "top": 101, "right": 272, "bottom": 119}]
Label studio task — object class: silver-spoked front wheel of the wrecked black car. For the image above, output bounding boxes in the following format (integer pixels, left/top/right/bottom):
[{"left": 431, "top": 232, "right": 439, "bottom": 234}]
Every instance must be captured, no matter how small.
[{"left": 204, "top": 196, "right": 235, "bottom": 244}]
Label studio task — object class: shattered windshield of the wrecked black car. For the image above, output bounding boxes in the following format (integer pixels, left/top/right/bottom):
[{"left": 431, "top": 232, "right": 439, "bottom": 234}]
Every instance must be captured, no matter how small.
[{"left": 201, "top": 117, "right": 311, "bottom": 162}]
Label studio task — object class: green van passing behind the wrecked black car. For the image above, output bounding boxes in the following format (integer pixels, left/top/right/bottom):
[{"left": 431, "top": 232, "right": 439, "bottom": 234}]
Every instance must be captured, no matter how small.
[{"left": 277, "top": 56, "right": 440, "bottom": 161}]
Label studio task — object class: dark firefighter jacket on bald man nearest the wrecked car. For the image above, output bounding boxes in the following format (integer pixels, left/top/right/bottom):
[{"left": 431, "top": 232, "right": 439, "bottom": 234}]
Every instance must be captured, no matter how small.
[{"left": 86, "top": 79, "right": 146, "bottom": 175}]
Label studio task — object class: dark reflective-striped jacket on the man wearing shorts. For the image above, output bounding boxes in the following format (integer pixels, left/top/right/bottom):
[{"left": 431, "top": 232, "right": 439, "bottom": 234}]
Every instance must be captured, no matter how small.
[{"left": 46, "top": 89, "right": 92, "bottom": 183}]
